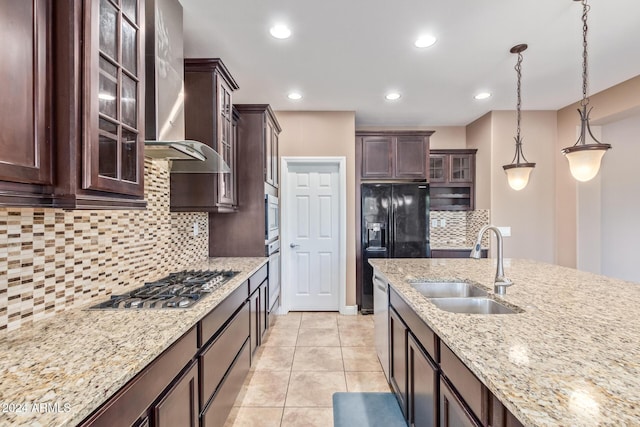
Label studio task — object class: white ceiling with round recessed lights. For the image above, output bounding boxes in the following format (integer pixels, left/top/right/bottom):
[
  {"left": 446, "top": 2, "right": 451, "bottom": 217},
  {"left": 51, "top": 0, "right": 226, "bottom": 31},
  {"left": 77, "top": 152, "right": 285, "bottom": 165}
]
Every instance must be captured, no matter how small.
[{"left": 180, "top": 0, "right": 640, "bottom": 126}]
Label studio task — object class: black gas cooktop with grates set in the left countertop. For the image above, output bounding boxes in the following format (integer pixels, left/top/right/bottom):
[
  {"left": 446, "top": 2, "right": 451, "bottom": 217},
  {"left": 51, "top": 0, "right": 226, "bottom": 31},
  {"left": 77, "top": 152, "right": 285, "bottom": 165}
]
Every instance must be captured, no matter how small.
[{"left": 89, "top": 270, "right": 237, "bottom": 309}]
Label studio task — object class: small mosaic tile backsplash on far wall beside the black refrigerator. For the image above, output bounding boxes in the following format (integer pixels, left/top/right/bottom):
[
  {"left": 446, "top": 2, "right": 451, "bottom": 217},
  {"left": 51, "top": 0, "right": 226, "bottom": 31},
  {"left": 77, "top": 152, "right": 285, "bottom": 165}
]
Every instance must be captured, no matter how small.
[{"left": 429, "top": 209, "right": 489, "bottom": 248}]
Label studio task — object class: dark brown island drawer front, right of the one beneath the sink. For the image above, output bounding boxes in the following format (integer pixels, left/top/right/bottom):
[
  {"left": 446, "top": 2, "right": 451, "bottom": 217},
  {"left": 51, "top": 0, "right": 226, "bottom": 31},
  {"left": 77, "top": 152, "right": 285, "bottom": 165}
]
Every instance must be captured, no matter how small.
[{"left": 440, "top": 343, "right": 487, "bottom": 419}]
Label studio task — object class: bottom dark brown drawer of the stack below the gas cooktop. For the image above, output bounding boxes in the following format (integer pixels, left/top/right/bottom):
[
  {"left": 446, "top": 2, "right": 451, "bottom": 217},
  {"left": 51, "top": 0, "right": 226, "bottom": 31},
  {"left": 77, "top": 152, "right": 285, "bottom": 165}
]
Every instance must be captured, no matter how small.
[{"left": 201, "top": 340, "right": 251, "bottom": 427}]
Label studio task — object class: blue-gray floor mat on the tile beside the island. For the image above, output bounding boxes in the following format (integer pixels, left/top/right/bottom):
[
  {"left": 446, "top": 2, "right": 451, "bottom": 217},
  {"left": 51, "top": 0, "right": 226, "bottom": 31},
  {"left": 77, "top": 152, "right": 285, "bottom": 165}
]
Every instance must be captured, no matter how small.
[{"left": 333, "top": 392, "right": 407, "bottom": 427}]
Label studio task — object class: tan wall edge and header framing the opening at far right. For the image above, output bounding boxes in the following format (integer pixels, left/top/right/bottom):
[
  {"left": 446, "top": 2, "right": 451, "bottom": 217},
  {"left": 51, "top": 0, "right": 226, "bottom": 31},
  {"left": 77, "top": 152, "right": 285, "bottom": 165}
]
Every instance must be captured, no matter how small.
[{"left": 554, "top": 76, "right": 640, "bottom": 267}]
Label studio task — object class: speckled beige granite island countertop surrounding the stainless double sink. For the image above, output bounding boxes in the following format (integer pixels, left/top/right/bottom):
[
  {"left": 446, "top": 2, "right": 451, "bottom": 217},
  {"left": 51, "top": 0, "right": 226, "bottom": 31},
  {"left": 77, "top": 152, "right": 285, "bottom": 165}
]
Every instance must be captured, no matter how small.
[{"left": 370, "top": 259, "right": 640, "bottom": 426}]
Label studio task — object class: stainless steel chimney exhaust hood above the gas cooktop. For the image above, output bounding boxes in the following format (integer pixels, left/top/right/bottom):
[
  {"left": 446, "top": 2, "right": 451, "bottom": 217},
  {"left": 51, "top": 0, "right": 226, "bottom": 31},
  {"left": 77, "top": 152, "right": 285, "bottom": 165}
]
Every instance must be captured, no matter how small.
[{"left": 144, "top": 0, "right": 231, "bottom": 173}]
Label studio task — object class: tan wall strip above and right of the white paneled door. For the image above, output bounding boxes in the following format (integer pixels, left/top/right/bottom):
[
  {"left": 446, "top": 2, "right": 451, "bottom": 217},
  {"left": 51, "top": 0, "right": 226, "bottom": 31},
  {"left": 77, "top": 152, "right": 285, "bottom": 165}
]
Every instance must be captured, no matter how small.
[{"left": 276, "top": 111, "right": 356, "bottom": 305}]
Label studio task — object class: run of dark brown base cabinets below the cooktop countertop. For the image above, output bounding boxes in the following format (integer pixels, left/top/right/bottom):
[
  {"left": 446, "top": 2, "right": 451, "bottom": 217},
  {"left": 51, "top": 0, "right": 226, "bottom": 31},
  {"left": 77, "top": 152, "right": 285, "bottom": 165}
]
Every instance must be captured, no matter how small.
[{"left": 79, "top": 264, "right": 269, "bottom": 427}]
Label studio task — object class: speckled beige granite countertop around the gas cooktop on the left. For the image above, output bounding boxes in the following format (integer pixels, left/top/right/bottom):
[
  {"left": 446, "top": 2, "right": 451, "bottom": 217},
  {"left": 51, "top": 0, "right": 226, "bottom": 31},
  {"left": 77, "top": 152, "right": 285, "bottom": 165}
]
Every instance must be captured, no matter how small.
[{"left": 0, "top": 258, "right": 268, "bottom": 427}]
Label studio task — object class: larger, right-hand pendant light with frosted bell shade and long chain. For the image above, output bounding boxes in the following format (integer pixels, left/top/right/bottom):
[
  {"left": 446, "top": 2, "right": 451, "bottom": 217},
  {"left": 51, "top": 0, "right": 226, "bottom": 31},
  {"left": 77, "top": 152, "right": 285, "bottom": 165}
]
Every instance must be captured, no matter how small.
[{"left": 562, "top": 0, "right": 611, "bottom": 182}]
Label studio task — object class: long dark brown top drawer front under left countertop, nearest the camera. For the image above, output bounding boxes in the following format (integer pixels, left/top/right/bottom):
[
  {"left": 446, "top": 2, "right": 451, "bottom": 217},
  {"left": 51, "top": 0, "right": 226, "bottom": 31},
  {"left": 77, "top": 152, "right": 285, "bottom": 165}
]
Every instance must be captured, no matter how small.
[{"left": 80, "top": 328, "right": 196, "bottom": 427}]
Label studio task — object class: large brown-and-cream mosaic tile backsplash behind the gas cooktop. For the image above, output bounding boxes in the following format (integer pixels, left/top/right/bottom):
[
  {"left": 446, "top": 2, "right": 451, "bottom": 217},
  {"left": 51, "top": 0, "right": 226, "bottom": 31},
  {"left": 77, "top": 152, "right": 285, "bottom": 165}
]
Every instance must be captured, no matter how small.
[{"left": 0, "top": 159, "right": 209, "bottom": 333}]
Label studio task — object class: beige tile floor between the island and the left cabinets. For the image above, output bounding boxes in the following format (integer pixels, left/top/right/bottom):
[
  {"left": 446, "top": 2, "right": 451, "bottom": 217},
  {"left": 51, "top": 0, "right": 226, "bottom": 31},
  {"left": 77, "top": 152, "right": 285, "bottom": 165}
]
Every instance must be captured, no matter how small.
[{"left": 225, "top": 312, "right": 390, "bottom": 427}]
